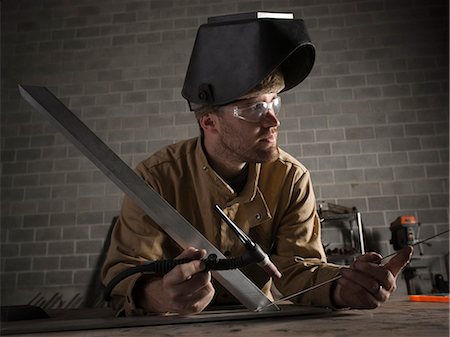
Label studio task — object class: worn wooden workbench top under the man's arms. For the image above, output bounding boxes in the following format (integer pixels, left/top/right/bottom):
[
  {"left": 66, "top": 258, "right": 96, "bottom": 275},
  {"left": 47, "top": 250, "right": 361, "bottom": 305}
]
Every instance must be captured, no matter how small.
[{"left": 1, "top": 299, "right": 449, "bottom": 337}]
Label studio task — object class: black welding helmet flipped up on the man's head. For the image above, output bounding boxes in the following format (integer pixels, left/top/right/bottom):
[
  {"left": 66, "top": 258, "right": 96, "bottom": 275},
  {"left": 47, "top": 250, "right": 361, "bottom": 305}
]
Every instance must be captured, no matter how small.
[{"left": 181, "top": 12, "right": 315, "bottom": 111}]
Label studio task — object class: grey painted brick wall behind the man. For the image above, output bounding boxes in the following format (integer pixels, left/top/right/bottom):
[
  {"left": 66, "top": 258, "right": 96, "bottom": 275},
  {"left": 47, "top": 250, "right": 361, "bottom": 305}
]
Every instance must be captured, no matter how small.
[{"left": 1, "top": 0, "right": 449, "bottom": 303}]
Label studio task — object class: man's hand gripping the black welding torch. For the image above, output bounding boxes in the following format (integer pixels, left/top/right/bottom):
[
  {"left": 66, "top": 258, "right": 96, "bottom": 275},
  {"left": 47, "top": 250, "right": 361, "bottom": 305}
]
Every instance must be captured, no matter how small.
[{"left": 134, "top": 247, "right": 214, "bottom": 314}]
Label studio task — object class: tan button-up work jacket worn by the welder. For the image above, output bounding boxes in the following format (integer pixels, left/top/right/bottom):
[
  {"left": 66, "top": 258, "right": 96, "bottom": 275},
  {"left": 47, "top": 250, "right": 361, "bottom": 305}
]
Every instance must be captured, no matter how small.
[{"left": 102, "top": 138, "right": 339, "bottom": 315}]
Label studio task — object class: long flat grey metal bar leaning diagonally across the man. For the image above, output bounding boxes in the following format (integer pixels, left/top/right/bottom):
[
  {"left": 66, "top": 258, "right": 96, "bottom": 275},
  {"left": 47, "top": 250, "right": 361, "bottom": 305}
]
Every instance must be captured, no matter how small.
[{"left": 19, "top": 85, "right": 278, "bottom": 311}]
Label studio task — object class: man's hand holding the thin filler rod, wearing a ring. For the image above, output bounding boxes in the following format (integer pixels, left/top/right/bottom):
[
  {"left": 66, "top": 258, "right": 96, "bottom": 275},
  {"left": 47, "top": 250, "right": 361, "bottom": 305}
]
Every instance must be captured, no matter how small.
[{"left": 331, "top": 247, "right": 413, "bottom": 309}]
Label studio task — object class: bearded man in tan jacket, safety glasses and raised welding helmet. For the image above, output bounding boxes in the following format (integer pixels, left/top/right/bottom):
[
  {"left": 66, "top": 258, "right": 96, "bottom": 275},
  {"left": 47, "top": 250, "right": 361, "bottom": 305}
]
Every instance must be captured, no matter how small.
[{"left": 103, "top": 13, "right": 412, "bottom": 315}]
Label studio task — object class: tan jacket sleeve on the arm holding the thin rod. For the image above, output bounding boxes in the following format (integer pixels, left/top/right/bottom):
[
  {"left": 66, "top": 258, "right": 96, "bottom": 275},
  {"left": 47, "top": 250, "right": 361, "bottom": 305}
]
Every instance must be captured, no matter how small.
[{"left": 272, "top": 171, "right": 341, "bottom": 307}]
